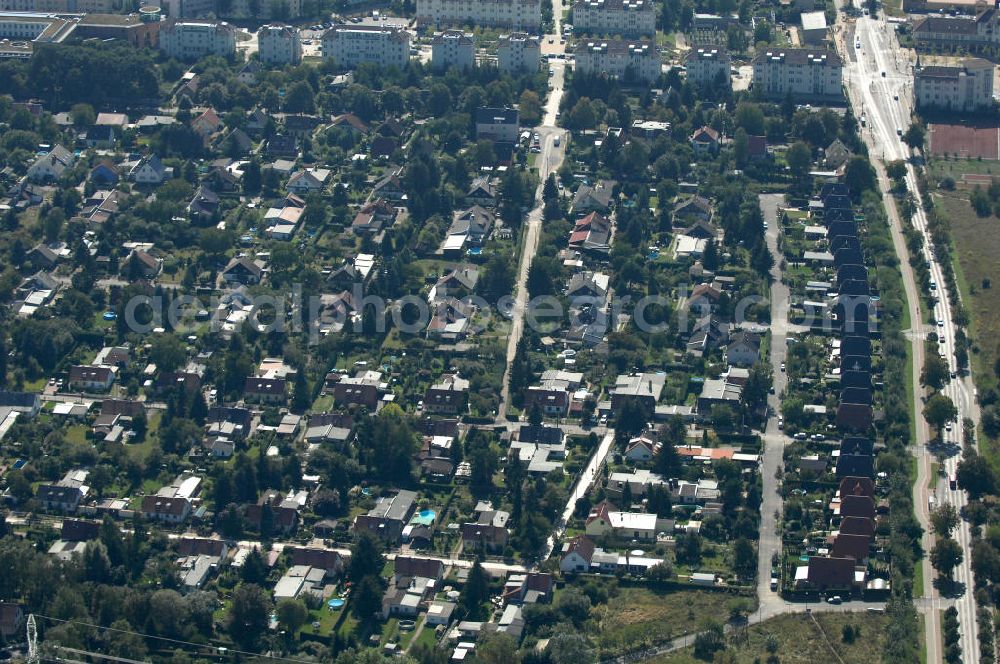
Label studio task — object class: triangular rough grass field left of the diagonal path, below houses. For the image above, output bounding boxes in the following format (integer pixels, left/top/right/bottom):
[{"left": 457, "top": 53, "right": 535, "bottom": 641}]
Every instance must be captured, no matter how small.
[{"left": 595, "top": 588, "right": 748, "bottom": 658}]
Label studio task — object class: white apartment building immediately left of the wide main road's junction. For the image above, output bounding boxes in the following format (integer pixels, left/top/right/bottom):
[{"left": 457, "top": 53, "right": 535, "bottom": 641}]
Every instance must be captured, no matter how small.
[{"left": 753, "top": 48, "right": 844, "bottom": 101}]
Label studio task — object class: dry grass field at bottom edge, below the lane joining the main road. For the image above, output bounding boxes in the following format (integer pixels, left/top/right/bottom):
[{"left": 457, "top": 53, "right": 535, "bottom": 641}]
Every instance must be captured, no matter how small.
[{"left": 650, "top": 613, "right": 887, "bottom": 664}]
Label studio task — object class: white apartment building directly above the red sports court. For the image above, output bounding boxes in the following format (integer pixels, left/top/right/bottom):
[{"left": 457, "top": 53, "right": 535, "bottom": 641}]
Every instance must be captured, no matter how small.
[{"left": 913, "top": 58, "right": 994, "bottom": 113}]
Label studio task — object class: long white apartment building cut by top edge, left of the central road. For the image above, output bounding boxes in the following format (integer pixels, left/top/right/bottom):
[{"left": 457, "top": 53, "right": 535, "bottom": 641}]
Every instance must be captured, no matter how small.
[{"left": 417, "top": 0, "right": 542, "bottom": 32}]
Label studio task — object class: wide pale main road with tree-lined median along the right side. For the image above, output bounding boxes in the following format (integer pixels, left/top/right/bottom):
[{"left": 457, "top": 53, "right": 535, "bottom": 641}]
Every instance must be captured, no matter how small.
[{"left": 839, "top": 9, "right": 979, "bottom": 662}]
